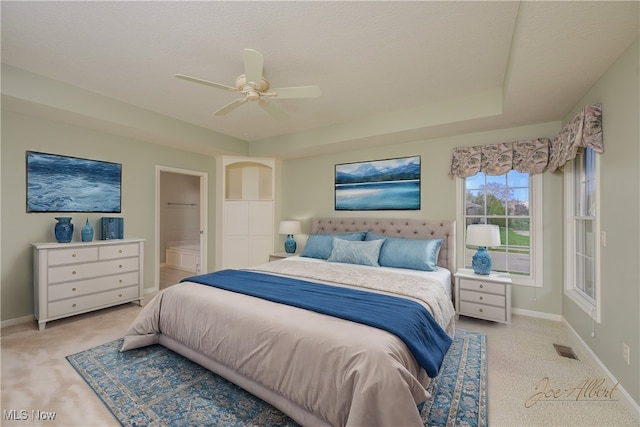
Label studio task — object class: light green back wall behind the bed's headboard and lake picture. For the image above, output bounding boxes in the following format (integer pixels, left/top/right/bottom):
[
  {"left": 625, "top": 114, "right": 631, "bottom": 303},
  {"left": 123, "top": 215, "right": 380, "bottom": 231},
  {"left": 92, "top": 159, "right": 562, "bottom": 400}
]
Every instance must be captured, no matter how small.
[{"left": 277, "top": 122, "right": 563, "bottom": 316}]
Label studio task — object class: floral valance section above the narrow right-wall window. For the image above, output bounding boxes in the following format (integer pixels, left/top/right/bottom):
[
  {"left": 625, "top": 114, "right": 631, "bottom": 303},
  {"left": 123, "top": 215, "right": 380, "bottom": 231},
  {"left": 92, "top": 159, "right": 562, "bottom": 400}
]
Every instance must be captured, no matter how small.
[{"left": 549, "top": 104, "right": 604, "bottom": 172}]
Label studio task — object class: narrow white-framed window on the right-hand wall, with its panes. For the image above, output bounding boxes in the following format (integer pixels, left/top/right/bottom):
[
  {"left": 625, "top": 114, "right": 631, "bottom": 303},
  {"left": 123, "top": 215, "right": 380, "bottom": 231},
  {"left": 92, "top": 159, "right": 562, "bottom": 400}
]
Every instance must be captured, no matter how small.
[{"left": 565, "top": 148, "right": 600, "bottom": 322}]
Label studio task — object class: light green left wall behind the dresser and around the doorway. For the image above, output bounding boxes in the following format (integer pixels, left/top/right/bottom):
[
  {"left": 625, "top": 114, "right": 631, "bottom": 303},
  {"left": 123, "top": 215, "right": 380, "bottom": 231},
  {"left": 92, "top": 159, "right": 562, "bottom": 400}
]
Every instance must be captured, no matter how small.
[{"left": 0, "top": 110, "right": 215, "bottom": 321}]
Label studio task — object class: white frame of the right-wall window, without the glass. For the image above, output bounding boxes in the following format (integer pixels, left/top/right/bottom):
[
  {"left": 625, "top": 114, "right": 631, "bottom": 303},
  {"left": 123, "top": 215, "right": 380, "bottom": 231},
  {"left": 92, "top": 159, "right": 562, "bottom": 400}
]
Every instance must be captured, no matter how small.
[{"left": 564, "top": 148, "right": 601, "bottom": 323}]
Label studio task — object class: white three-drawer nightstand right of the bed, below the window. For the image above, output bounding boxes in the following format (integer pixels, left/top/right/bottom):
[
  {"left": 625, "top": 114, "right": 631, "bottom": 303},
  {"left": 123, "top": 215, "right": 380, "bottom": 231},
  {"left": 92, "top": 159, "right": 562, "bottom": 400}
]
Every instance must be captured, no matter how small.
[{"left": 455, "top": 268, "right": 511, "bottom": 323}]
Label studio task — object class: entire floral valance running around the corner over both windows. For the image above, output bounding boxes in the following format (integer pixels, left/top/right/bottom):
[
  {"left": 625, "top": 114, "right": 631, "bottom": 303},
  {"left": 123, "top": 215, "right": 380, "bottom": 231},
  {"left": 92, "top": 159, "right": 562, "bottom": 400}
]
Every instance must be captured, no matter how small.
[{"left": 449, "top": 104, "right": 604, "bottom": 178}]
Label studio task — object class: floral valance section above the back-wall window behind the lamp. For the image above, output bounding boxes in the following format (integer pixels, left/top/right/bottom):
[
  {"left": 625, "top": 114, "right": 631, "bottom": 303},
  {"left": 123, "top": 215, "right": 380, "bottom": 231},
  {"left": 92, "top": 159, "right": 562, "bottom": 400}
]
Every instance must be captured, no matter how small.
[{"left": 449, "top": 138, "right": 551, "bottom": 178}]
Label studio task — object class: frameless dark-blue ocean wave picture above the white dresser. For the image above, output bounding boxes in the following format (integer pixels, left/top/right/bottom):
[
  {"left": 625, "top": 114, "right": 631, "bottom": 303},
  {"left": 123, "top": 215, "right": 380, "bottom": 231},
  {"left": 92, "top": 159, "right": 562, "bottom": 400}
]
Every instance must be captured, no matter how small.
[{"left": 26, "top": 151, "right": 122, "bottom": 213}]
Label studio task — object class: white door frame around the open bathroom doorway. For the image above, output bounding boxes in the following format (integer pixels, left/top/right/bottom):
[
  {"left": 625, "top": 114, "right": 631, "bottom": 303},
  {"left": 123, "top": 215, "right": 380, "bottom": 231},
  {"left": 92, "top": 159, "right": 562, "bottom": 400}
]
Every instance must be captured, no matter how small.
[{"left": 154, "top": 165, "right": 209, "bottom": 292}]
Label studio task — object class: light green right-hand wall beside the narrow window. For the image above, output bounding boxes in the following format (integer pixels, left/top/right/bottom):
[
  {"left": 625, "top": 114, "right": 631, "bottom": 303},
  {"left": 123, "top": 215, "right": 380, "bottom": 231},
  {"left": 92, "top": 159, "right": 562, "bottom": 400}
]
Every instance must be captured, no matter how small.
[{"left": 562, "top": 40, "right": 640, "bottom": 404}]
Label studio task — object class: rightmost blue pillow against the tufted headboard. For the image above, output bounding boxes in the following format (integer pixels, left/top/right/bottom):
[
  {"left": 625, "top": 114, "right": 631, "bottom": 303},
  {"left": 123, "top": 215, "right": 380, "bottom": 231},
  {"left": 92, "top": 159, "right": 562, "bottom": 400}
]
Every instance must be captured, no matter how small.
[{"left": 365, "top": 233, "right": 442, "bottom": 271}]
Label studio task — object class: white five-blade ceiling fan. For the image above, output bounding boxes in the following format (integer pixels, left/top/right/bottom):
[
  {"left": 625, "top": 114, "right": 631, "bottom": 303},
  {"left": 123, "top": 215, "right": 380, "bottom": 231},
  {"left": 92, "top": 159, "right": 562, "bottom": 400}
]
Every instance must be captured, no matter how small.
[{"left": 175, "top": 49, "right": 322, "bottom": 120}]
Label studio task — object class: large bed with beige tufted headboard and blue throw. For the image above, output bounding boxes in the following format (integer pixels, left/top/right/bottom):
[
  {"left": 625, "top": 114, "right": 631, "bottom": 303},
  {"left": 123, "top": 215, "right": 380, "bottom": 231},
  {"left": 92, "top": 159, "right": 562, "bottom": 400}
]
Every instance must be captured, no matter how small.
[{"left": 122, "top": 218, "right": 455, "bottom": 426}]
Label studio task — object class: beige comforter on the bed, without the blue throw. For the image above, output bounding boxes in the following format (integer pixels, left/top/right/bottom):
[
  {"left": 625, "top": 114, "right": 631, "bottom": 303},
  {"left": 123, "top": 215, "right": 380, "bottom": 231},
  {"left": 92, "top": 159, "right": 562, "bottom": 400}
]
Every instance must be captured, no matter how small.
[{"left": 123, "top": 260, "right": 454, "bottom": 426}]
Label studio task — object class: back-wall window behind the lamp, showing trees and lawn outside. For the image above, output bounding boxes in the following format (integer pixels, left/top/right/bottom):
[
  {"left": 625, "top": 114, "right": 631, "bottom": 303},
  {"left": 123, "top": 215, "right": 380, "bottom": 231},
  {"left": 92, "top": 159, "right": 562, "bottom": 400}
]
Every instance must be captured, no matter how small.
[{"left": 458, "top": 170, "right": 542, "bottom": 286}]
